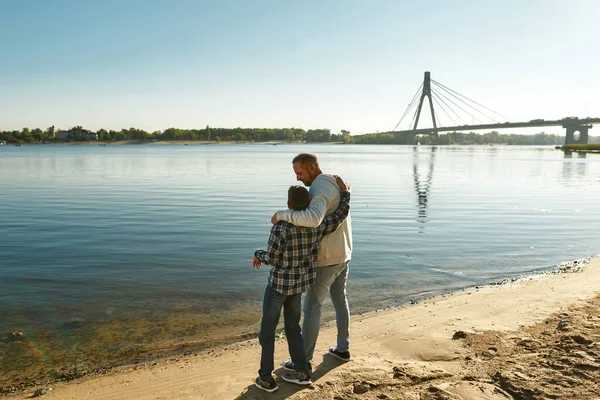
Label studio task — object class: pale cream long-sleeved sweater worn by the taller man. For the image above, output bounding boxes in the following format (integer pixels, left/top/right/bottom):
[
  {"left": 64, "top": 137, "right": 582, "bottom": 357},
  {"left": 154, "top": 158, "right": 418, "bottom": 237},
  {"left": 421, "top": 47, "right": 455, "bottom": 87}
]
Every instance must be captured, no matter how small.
[{"left": 277, "top": 174, "right": 352, "bottom": 267}]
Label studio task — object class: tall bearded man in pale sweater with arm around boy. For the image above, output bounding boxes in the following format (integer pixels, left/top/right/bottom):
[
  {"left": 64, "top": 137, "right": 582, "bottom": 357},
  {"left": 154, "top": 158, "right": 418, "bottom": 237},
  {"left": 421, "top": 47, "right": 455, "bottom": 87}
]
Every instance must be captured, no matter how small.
[{"left": 271, "top": 153, "right": 352, "bottom": 371}]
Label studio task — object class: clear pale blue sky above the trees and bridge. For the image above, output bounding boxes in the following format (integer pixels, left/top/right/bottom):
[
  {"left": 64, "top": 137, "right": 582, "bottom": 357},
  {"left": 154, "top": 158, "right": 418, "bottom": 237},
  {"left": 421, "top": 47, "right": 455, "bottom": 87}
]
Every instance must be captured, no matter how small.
[{"left": 0, "top": 0, "right": 600, "bottom": 134}]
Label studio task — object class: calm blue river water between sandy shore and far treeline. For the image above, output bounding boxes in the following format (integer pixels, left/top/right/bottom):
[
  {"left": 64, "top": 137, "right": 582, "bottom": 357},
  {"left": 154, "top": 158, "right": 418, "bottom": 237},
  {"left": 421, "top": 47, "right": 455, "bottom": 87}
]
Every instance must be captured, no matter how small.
[{"left": 0, "top": 145, "right": 600, "bottom": 386}]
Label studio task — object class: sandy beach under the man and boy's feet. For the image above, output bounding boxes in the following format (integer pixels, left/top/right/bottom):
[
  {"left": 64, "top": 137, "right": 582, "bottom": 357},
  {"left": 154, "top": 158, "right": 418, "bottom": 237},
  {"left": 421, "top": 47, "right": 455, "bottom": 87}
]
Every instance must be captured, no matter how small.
[{"left": 7, "top": 258, "right": 600, "bottom": 400}]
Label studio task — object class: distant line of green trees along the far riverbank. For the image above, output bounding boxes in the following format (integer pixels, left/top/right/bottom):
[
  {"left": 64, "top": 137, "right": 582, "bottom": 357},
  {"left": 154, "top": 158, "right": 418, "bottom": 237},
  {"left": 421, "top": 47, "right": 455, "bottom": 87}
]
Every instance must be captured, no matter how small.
[{"left": 0, "top": 125, "right": 600, "bottom": 145}]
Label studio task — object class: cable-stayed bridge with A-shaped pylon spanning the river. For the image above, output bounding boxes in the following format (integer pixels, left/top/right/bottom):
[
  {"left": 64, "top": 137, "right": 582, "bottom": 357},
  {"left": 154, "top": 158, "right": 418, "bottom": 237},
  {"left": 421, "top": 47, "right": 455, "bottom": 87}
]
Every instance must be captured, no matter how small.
[{"left": 393, "top": 72, "right": 600, "bottom": 144}]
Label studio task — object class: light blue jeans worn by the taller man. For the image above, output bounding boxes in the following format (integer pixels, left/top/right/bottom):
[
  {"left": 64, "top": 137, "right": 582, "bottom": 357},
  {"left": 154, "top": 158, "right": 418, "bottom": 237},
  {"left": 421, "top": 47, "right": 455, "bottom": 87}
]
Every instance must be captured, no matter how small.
[{"left": 302, "top": 261, "right": 350, "bottom": 362}]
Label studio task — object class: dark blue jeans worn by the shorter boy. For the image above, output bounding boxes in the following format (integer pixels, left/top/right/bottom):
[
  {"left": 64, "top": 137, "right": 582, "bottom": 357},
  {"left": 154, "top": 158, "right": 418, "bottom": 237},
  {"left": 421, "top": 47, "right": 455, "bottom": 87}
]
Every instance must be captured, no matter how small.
[{"left": 258, "top": 285, "right": 309, "bottom": 380}]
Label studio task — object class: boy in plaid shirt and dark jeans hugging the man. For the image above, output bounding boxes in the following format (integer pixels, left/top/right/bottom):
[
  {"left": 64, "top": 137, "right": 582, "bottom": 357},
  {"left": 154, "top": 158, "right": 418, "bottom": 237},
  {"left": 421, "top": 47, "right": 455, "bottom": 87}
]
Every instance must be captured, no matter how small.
[{"left": 252, "top": 176, "right": 350, "bottom": 392}]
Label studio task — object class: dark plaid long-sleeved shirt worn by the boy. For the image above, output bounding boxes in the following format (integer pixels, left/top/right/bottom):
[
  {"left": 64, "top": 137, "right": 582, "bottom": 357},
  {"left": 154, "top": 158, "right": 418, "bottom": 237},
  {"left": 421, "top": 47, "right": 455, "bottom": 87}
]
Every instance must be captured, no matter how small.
[{"left": 254, "top": 191, "right": 350, "bottom": 296}]
